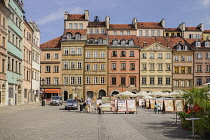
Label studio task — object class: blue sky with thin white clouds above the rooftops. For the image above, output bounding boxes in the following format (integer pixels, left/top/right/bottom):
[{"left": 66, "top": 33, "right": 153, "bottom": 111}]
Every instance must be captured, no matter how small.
[{"left": 24, "top": 0, "right": 210, "bottom": 43}]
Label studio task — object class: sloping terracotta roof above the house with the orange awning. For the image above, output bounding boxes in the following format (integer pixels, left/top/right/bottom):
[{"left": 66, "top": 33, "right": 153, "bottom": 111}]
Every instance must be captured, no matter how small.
[{"left": 40, "top": 36, "right": 62, "bottom": 49}]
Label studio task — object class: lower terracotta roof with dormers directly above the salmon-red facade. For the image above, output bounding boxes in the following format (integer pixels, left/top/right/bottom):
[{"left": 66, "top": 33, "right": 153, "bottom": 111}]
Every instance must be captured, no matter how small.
[{"left": 108, "top": 35, "right": 139, "bottom": 46}]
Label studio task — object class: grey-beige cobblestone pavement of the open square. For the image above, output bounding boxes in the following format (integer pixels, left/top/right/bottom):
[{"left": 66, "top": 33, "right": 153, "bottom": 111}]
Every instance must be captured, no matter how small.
[{"left": 0, "top": 104, "right": 204, "bottom": 140}]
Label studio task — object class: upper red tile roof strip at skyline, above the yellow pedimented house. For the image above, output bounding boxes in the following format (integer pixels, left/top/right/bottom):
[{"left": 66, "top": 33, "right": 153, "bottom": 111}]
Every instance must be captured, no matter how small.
[{"left": 137, "top": 22, "right": 163, "bottom": 29}]
